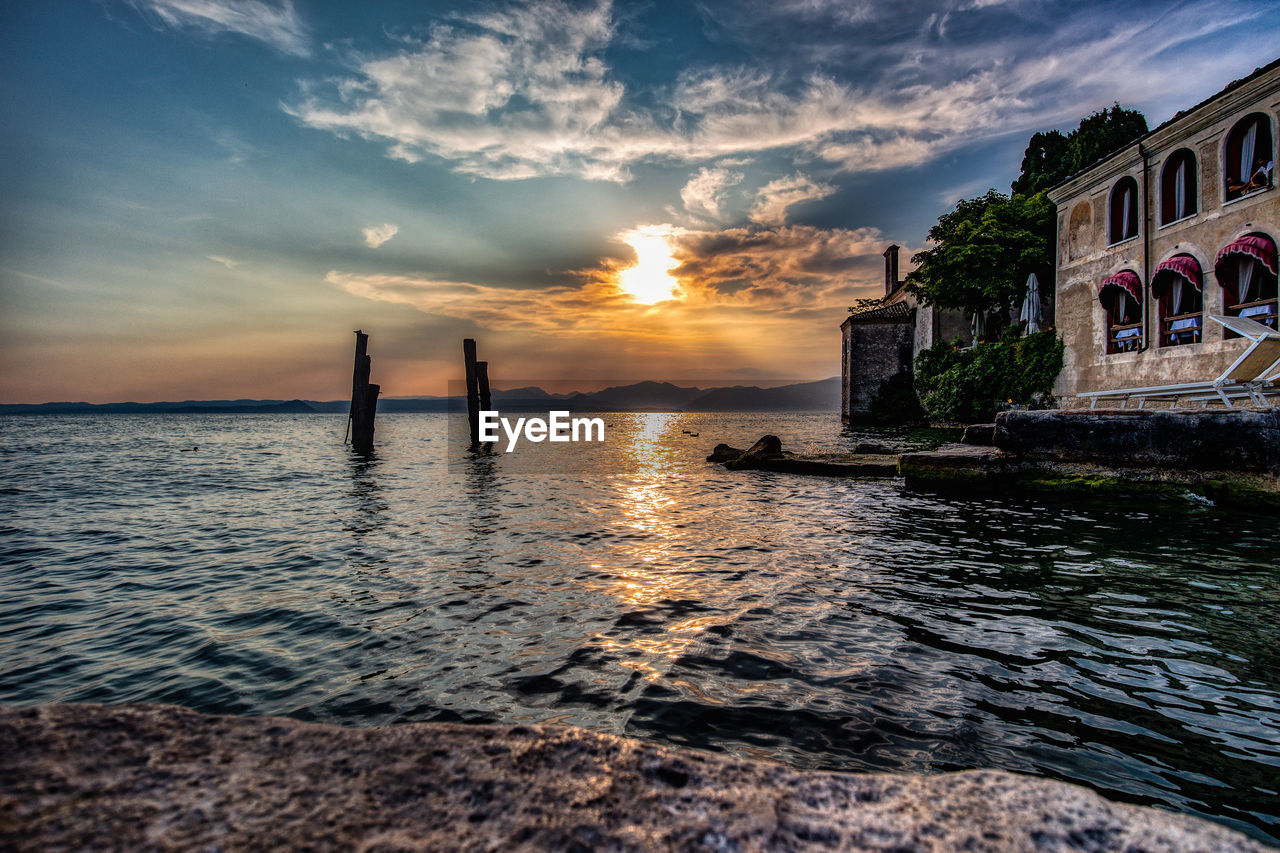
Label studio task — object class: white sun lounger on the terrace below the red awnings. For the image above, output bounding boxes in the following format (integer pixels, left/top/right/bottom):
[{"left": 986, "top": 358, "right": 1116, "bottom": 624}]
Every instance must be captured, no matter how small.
[{"left": 1078, "top": 314, "right": 1280, "bottom": 409}]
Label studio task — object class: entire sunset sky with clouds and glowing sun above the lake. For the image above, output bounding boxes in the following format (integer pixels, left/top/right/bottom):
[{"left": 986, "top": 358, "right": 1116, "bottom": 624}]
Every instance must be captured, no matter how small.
[{"left": 0, "top": 0, "right": 1280, "bottom": 402}]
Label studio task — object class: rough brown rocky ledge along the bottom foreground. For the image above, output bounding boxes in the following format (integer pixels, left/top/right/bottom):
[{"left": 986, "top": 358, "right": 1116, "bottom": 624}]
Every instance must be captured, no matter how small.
[{"left": 0, "top": 704, "right": 1263, "bottom": 853}]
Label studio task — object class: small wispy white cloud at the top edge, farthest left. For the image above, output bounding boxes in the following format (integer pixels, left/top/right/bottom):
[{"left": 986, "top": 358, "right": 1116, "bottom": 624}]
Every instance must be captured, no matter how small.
[{"left": 127, "top": 0, "right": 308, "bottom": 56}]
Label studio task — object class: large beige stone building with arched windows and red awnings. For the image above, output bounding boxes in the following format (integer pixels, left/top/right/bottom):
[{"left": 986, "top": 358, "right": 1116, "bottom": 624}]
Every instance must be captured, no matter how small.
[{"left": 1048, "top": 60, "right": 1280, "bottom": 407}]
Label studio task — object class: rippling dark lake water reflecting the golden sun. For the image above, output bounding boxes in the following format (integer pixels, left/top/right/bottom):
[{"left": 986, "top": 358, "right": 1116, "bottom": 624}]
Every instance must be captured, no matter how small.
[{"left": 0, "top": 414, "right": 1280, "bottom": 843}]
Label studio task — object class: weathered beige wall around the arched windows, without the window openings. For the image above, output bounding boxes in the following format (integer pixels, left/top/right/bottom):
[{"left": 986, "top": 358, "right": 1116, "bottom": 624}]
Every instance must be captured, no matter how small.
[{"left": 1050, "top": 67, "right": 1280, "bottom": 407}]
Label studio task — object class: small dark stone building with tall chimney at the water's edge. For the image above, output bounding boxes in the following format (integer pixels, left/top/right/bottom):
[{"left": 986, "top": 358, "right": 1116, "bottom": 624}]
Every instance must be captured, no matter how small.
[{"left": 840, "top": 246, "right": 969, "bottom": 423}]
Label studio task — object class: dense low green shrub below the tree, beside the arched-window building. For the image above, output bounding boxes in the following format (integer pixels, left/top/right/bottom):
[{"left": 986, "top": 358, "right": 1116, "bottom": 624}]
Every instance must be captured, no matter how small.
[{"left": 915, "top": 332, "right": 1062, "bottom": 424}]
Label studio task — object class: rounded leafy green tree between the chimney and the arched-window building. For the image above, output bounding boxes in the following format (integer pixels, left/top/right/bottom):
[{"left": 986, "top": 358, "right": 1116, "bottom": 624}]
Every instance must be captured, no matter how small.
[{"left": 906, "top": 190, "right": 1055, "bottom": 324}]
